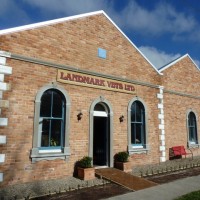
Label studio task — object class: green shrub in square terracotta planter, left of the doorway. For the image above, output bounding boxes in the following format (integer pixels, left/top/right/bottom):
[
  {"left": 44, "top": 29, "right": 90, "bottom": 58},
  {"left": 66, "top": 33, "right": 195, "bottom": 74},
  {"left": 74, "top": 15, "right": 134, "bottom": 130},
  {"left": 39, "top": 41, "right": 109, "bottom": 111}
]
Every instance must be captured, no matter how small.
[{"left": 78, "top": 156, "right": 95, "bottom": 180}]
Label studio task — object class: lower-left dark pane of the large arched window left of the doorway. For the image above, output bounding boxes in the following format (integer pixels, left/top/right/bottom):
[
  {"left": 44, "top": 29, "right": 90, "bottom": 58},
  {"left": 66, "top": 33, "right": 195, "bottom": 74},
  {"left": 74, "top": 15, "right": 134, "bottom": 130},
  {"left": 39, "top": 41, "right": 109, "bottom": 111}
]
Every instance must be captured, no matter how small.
[{"left": 41, "top": 119, "right": 50, "bottom": 147}]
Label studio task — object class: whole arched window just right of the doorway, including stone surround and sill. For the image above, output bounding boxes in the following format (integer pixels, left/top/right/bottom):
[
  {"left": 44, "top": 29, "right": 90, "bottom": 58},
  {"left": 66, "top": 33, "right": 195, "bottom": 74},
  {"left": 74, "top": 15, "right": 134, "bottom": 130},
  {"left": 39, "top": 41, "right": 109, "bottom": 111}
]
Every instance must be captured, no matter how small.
[{"left": 128, "top": 97, "right": 148, "bottom": 153}]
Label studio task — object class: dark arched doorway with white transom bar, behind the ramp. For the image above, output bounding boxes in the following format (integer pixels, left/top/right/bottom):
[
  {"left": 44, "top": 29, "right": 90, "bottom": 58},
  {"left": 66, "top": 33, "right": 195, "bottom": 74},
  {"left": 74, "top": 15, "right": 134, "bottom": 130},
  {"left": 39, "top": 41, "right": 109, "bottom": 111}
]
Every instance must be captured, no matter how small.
[{"left": 93, "top": 104, "right": 110, "bottom": 166}]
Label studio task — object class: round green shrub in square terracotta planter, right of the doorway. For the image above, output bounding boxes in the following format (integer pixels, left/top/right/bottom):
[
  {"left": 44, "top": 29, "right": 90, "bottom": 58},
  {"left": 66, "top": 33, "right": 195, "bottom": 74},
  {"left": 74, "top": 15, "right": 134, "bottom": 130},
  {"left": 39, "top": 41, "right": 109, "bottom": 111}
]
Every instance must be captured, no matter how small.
[{"left": 114, "top": 151, "right": 132, "bottom": 172}]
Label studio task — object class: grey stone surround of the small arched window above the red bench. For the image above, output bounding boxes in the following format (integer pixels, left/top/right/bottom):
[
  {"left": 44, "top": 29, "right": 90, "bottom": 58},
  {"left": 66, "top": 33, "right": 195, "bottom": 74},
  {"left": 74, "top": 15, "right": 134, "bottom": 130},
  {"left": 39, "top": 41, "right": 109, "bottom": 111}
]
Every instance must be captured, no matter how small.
[{"left": 186, "top": 109, "right": 200, "bottom": 148}]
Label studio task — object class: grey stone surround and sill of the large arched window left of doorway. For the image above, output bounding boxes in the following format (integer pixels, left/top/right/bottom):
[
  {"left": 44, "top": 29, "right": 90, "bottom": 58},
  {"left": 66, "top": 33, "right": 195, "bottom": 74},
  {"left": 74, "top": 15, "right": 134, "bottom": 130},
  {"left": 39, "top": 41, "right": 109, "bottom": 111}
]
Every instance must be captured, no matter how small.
[{"left": 30, "top": 83, "right": 71, "bottom": 163}]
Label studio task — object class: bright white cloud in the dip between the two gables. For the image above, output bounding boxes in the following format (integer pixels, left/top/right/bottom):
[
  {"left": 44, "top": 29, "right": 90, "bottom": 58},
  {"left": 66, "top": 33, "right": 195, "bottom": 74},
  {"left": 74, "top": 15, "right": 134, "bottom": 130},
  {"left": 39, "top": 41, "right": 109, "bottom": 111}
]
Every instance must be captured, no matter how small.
[{"left": 139, "top": 46, "right": 181, "bottom": 69}]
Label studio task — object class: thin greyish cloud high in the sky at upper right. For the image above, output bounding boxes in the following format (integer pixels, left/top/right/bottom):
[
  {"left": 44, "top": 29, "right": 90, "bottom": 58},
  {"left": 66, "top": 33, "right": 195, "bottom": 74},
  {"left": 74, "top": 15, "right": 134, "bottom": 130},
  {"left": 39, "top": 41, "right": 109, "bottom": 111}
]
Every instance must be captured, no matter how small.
[{"left": 120, "top": 1, "right": 198, "bottom": 35}]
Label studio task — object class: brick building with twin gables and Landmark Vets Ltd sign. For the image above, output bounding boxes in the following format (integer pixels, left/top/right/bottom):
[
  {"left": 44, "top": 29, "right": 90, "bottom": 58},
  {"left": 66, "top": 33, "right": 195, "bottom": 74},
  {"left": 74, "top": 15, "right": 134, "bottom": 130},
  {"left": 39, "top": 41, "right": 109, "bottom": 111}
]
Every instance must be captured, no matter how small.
[{"left": 0, "top": 11, "right": 200, "bottom": 187}]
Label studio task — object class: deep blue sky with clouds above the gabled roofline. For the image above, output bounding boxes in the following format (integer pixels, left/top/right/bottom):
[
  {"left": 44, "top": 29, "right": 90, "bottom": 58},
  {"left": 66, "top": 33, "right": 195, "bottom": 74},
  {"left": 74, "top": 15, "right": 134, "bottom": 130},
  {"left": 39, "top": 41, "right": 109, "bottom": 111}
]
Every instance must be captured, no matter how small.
[{"left": 0, "top": 0, "right": 200, "bottom": 68}]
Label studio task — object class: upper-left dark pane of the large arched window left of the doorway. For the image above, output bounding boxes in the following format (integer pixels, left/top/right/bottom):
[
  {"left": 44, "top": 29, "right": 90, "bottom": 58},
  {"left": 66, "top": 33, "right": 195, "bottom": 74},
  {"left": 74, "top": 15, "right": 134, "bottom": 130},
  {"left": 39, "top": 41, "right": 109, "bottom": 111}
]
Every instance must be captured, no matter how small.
[{"left": 40, "top": 90, "right": 52, "bottom": 117}]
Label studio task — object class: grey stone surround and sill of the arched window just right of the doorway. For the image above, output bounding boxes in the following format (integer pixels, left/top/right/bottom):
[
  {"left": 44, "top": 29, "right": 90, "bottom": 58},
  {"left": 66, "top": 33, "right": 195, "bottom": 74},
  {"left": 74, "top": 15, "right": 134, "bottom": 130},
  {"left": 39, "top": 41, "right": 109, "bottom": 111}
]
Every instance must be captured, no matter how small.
[{"left": 128, "top": 97, "right": 149, "bottom": 154}]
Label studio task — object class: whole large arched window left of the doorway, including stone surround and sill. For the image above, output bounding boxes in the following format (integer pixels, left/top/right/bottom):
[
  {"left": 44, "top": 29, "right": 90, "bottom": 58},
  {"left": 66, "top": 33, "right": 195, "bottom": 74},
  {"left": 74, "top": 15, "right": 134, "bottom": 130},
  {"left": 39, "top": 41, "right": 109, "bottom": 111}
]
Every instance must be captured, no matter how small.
[{"left": 31, "top": 84, "right": 70, "bottom": 162}]
